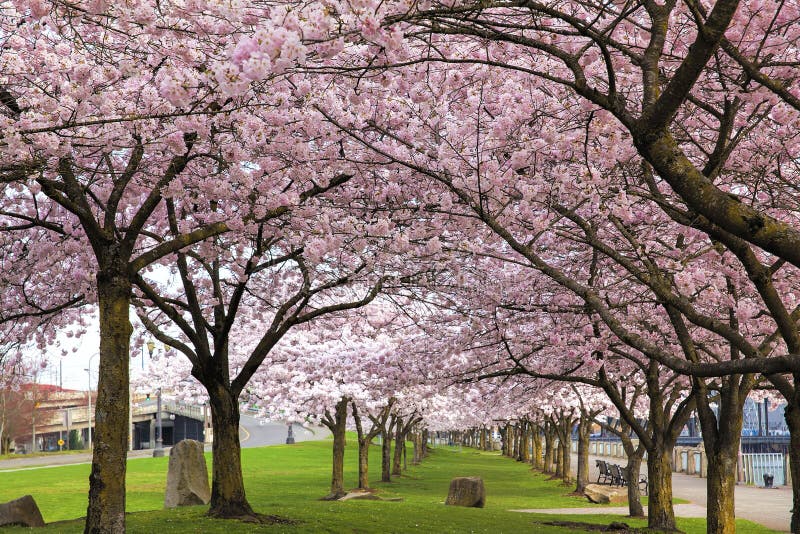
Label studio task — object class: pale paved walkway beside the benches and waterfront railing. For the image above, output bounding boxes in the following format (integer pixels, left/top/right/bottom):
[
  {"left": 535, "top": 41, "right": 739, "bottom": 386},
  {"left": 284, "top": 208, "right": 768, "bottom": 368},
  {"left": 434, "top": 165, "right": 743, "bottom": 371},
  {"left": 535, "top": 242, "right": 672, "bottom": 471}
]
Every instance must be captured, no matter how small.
[{"left": 568, "top": 454, "right": 792, "bottom": 532}]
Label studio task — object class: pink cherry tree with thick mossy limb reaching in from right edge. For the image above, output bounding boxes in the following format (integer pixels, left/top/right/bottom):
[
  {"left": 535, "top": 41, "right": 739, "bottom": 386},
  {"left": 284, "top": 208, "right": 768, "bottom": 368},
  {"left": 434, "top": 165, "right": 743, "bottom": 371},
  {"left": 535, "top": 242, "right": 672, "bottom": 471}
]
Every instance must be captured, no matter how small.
[{"left": 342, "top": 0, "right": 800, "bottom": 531}]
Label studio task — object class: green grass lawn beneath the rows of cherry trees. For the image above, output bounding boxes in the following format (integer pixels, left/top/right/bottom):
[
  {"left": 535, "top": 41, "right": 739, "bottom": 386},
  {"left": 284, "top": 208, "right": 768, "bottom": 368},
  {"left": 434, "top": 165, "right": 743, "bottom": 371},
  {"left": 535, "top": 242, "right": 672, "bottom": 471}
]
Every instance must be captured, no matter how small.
[{"left": 0, "top": 441, "right": 771, "bottom": 534}]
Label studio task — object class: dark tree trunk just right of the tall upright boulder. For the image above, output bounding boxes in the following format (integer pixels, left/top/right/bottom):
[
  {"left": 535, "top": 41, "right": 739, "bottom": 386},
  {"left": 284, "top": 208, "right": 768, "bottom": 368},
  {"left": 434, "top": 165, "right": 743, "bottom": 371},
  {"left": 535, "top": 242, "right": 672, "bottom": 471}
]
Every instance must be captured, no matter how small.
[{"left": 206, "top": 382, "right": 255, "bottom": 519}]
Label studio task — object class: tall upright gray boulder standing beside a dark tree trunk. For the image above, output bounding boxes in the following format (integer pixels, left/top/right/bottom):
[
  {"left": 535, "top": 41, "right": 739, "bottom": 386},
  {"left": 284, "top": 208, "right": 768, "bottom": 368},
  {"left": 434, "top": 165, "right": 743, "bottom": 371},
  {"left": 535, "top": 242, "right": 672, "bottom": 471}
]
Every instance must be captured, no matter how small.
[{"left": 164, "top": 439, "right": 211, "bottom": 508}]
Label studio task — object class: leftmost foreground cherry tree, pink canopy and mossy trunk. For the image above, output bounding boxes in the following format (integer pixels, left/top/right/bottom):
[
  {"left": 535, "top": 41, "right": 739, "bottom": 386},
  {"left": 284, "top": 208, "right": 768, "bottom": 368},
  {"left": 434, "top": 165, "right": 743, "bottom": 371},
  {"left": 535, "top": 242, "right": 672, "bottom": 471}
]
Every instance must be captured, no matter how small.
[{"left": 0, "top": 0, "right": 324, "bottom": 532}]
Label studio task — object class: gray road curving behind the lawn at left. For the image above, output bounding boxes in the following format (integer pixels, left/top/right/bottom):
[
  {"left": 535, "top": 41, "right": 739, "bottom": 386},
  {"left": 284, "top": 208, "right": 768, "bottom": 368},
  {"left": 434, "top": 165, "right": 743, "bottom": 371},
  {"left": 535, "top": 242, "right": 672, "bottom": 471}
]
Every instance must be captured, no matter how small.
[{"left": 0, "top": 415, "right": 330, "bottom": 472}]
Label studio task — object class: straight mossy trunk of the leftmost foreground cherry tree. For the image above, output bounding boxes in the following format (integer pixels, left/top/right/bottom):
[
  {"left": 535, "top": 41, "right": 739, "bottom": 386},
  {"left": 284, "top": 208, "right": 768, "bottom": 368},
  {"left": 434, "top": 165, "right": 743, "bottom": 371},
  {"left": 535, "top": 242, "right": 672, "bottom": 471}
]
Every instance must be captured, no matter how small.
[{"left": 84, "top": 271, "right": 133, "bottom": 534}]
